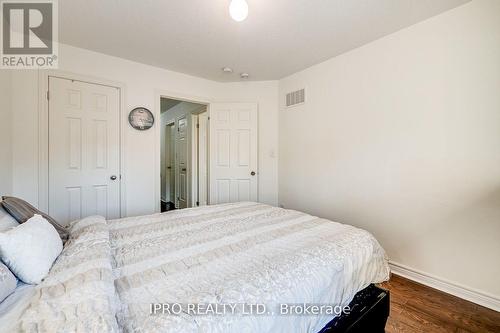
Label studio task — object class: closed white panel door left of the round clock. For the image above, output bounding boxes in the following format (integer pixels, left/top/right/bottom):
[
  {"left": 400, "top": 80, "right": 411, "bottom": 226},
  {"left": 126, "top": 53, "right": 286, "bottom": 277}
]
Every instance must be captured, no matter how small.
[{"left": 49, "top": 77, "right": 120, "bottom": 223}]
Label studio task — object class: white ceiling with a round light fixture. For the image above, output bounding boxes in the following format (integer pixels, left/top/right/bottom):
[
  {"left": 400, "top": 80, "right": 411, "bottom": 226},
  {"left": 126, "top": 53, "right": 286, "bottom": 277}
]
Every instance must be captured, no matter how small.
[{"left": 59, "top": 0, "right": 470, "bottom": 81}]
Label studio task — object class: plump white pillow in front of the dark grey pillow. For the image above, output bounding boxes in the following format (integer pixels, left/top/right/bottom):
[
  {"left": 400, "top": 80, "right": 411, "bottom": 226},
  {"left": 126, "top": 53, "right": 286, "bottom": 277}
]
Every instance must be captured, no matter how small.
[{"left": 0, "top": 214, "right": 63, "bottom": 284}]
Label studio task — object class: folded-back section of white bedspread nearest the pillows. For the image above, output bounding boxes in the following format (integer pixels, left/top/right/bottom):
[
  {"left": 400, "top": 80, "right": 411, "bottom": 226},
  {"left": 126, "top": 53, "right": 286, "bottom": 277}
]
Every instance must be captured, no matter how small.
[{"left": 14, "top": 216, "right": 120, "bottom": 333}]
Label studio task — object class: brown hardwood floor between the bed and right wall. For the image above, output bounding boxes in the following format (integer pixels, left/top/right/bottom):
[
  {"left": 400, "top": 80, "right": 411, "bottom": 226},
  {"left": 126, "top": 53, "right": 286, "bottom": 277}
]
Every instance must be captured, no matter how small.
[{"left": 379, "top": 274, "right": 500, "bottom": 333}]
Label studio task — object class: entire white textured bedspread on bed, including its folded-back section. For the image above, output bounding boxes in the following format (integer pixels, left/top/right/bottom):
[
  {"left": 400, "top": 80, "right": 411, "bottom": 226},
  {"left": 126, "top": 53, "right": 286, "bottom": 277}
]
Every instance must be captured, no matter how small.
[{"left": 0, "top": 202, "right": 389, "bottom": 332}]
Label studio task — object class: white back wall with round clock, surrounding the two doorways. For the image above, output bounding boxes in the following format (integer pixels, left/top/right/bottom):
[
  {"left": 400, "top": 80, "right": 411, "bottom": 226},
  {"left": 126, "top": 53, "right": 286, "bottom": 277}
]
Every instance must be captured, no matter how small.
[{"left": 7, "top": 45, "right": 278, "bottom": 216}]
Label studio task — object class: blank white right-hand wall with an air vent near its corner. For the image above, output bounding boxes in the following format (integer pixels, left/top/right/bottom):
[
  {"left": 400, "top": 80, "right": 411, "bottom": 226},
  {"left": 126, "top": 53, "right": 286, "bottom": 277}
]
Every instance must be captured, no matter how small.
[{"left": 279, "top": 0, "right": 500, "bottom": 298}]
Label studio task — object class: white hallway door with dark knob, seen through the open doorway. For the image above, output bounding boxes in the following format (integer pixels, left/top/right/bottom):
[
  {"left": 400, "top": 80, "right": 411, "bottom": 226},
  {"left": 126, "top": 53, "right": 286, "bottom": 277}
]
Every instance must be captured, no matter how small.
[{"left": 175, "top": 116, "right": 188, "bottom": 209}]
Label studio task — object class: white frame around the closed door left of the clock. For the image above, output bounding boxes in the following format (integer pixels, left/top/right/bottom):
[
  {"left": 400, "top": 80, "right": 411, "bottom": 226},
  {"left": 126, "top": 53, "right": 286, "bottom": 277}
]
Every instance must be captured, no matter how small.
[{"left": 37, "top": 70, "right": 128, "bottom": 217}]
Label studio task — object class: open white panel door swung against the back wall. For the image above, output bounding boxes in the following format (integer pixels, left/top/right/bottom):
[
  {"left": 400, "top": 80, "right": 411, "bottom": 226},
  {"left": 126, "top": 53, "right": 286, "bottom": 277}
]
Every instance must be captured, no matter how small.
[{"left": 209, "top": 103, "right": 258, "bottom": 204}]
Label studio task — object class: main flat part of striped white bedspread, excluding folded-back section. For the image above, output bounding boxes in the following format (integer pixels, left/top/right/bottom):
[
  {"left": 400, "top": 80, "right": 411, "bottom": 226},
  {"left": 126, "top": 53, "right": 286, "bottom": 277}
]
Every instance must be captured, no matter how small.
[{"left": 108, "top": 202, "right": 389, "bottom": 332}]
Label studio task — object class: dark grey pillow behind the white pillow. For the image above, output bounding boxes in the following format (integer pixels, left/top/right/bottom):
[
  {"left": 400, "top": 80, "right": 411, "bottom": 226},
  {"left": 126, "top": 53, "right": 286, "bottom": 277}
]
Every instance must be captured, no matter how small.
[{"left": 0, "top": 196, "right": 69, "bottom": 241}]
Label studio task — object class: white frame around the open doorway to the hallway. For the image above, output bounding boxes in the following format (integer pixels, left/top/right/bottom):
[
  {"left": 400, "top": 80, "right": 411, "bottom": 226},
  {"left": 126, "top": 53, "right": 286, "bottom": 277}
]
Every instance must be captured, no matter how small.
[{"left": 154, "top": 90, "right": 210, "bottom": 213}]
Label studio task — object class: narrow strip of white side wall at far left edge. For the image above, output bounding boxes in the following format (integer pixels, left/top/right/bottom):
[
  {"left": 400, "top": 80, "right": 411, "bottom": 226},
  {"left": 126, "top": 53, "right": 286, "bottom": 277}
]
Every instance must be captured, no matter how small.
[{"left": 0, "top": 70, "right": 12, "bottom": 196}]
